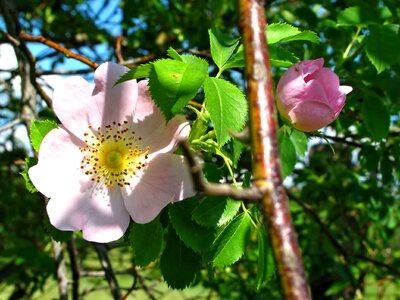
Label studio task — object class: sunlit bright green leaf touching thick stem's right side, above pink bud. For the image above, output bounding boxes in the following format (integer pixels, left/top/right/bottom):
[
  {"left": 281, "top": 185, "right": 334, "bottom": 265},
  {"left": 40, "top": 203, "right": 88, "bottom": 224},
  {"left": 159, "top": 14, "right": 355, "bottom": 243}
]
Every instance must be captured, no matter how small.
[{"left": 267, "top": 23, "right": 319, "bottom": 45}]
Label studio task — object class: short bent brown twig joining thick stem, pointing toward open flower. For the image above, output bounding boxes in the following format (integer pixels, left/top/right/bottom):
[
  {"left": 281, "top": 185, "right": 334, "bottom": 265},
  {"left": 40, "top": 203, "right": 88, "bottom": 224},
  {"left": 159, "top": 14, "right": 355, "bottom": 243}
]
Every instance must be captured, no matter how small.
[{"left": 179, "top": 140, "right": 262, "bottom": 202}]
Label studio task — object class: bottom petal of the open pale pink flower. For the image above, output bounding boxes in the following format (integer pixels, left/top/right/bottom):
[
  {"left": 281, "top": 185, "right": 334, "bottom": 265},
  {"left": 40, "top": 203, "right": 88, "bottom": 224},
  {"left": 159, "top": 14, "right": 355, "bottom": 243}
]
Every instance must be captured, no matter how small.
[{"left": 47, "top": 182, "right": 130, "bottom": 243}]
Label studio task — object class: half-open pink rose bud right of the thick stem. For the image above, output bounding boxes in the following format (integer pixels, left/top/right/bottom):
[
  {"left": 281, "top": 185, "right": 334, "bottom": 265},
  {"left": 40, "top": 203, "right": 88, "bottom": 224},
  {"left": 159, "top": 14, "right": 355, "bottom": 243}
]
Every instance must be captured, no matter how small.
[{"left": 277, "top": 58, "right": 353, "bottom": 132}]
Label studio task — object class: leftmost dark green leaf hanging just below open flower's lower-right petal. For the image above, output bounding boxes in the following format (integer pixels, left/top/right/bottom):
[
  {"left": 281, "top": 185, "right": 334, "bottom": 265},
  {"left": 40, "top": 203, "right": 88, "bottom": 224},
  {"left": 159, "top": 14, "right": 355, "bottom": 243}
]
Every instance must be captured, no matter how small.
[{"left": 129, "top": 219, "right": 163, "bottom": 267}]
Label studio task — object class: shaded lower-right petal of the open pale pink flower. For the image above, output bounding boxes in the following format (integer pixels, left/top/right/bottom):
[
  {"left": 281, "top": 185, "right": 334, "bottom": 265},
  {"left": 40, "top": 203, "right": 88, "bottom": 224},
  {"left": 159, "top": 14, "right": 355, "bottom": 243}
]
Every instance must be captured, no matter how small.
[{"left": 122, "top": 154, "right": 194, "bottom": 223}]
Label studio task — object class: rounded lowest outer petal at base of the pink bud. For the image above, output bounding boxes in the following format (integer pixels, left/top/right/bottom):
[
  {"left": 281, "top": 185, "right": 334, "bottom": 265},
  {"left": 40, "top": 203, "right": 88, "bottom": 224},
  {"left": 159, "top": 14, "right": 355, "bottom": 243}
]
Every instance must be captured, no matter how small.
[{"left": 289, "top": 100, "right": 335, "bottom": 132}]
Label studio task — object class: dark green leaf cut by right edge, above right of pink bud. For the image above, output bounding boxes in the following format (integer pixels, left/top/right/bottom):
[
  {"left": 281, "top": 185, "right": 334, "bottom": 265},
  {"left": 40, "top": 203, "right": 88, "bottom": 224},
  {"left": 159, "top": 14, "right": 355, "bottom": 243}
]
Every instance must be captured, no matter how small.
[{"left": 366, "top": 24, "right": 400, "bottom": 73}]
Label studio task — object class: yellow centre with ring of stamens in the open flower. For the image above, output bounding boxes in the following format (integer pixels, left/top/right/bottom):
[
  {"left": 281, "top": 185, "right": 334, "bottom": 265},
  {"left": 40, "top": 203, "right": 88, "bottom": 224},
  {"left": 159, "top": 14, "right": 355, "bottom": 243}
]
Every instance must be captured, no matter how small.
[{"left": 80, "top": 121, "right": 150, "bottom": 188}]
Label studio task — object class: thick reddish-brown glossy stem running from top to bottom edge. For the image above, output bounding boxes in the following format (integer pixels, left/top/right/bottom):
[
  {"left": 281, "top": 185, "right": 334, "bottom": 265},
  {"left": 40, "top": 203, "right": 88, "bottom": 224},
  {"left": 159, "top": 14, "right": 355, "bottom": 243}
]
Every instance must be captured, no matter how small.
[{"left": 239, "top": 0, "right": 310, "bottom": 300}]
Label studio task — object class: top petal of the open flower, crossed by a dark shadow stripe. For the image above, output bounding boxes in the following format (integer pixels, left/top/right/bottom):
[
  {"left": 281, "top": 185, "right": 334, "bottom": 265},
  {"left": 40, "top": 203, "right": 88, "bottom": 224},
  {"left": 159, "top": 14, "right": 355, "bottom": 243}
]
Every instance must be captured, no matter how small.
[{"left": 53, "top": 63, "right": 137, "bottom": 139}]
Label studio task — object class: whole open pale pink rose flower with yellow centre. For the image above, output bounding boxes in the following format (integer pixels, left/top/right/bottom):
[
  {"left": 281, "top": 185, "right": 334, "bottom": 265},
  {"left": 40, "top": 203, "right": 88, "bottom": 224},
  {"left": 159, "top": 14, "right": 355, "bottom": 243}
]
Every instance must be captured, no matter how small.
[{"left": 29, "top": 63, "right": 194, "bottom": 243}]
